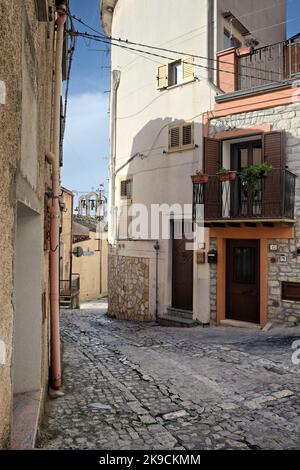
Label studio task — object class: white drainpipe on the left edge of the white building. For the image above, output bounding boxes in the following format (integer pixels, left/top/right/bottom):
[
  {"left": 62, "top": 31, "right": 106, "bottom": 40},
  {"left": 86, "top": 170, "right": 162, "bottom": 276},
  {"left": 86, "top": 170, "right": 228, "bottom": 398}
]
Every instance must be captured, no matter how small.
[{"left": 109, "top": 70, "right": 121, "bottom": 241}]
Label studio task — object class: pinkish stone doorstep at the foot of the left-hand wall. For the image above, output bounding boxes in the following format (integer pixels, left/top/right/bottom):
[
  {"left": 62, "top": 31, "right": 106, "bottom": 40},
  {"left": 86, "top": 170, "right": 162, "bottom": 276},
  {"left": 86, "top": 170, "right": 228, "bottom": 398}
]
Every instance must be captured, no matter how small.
[{"left": 11, "top": 390, "right": 42, "bottom": 450}]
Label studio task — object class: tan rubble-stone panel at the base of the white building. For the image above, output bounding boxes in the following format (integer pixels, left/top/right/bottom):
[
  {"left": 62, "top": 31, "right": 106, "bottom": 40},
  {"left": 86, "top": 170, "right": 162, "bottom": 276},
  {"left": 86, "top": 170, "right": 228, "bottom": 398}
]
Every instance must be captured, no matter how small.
[{"left": 108, "top": 253, "right": 153, "bottom": 321}]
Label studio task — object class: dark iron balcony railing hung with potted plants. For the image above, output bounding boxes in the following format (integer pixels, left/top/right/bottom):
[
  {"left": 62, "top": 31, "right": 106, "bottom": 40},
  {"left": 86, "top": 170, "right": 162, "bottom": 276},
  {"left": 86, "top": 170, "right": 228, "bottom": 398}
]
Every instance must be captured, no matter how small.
[{"left": 193, "top": 169, "right": 296, "bottom": 222}]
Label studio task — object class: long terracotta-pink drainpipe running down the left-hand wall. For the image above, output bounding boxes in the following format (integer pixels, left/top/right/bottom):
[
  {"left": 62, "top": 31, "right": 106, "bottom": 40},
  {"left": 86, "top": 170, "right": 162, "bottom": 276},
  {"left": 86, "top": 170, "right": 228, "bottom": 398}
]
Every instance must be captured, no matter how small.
[{"left": 50, "top": 3, "right": 67, "bottom": 390}]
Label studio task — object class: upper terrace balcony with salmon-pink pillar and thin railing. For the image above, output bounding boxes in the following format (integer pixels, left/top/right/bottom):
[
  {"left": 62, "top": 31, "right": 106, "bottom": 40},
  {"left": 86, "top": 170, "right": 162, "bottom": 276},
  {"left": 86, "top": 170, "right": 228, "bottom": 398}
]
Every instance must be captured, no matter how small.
[{"left": 217, "top": 40, "right": 300, "bottom": 93}]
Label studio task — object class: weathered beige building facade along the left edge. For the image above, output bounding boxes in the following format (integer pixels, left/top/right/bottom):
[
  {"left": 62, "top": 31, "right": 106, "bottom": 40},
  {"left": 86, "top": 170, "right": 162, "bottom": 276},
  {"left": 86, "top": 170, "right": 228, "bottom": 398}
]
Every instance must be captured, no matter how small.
[{"left": 0, "top": 0, "right": 65, "bottom": 448}]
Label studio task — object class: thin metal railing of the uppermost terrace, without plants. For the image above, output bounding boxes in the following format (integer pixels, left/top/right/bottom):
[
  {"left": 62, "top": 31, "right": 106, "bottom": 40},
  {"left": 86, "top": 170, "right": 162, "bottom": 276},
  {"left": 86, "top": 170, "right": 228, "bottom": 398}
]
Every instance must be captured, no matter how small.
[{"left": 237, "top": 42, "right": 300, "bottom": 90}]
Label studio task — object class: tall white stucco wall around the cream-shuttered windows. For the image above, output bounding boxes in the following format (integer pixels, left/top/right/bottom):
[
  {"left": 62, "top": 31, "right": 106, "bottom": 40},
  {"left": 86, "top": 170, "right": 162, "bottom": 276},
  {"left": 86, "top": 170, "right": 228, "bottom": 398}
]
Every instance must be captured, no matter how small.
[{"left": 110, "top": 0, "right": 284, "bottom": 322}]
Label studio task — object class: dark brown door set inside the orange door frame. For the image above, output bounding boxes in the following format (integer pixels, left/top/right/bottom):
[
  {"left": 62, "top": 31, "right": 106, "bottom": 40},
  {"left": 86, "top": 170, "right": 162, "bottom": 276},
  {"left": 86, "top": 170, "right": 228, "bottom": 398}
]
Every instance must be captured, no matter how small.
[{"left": 226, "top": 240, "right": 260, "bottom": 323}]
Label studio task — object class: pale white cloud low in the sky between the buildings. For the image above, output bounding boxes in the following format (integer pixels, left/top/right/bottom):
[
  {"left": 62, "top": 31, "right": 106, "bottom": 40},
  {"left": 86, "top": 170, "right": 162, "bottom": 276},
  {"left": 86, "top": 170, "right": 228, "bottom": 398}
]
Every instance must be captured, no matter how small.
[{"left": 62, "top": 93, "right": 109, "bottom": 191}]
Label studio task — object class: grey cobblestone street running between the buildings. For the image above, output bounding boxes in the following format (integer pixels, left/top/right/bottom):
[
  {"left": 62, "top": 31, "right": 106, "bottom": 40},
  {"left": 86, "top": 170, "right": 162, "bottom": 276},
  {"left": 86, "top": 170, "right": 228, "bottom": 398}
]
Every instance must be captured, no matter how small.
[{"left": 39, "top": 301, "right": 300, "bottom": 450}]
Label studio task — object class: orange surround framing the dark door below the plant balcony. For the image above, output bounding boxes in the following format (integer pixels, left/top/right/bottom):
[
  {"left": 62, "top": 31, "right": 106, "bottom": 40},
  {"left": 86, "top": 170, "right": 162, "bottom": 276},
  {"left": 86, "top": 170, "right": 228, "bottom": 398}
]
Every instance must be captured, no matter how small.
[{"left": 209, "top": 224, "right": 295, "bottom": 328}]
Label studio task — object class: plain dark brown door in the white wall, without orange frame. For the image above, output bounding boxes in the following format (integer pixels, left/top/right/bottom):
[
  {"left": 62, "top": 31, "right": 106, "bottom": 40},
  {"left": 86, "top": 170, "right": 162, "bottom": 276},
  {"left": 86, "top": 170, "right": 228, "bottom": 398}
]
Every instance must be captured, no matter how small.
[{"left": 172, "top": 224, "right": 193, "bottom": 312}]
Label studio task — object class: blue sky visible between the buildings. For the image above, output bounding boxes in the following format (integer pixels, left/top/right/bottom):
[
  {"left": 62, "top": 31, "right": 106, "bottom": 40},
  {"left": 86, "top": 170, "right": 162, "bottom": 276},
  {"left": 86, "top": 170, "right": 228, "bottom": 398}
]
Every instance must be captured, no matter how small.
[{"left": 62, "top": 0, "right": 300, "bottom": 199}]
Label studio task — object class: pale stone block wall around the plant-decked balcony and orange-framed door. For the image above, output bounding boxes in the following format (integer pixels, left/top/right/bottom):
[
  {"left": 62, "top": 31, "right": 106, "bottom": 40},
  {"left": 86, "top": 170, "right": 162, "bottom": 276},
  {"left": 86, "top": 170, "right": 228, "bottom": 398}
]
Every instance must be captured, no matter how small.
[{"left": 210, "top": 103, "right": 300, "bottom": 323}]
